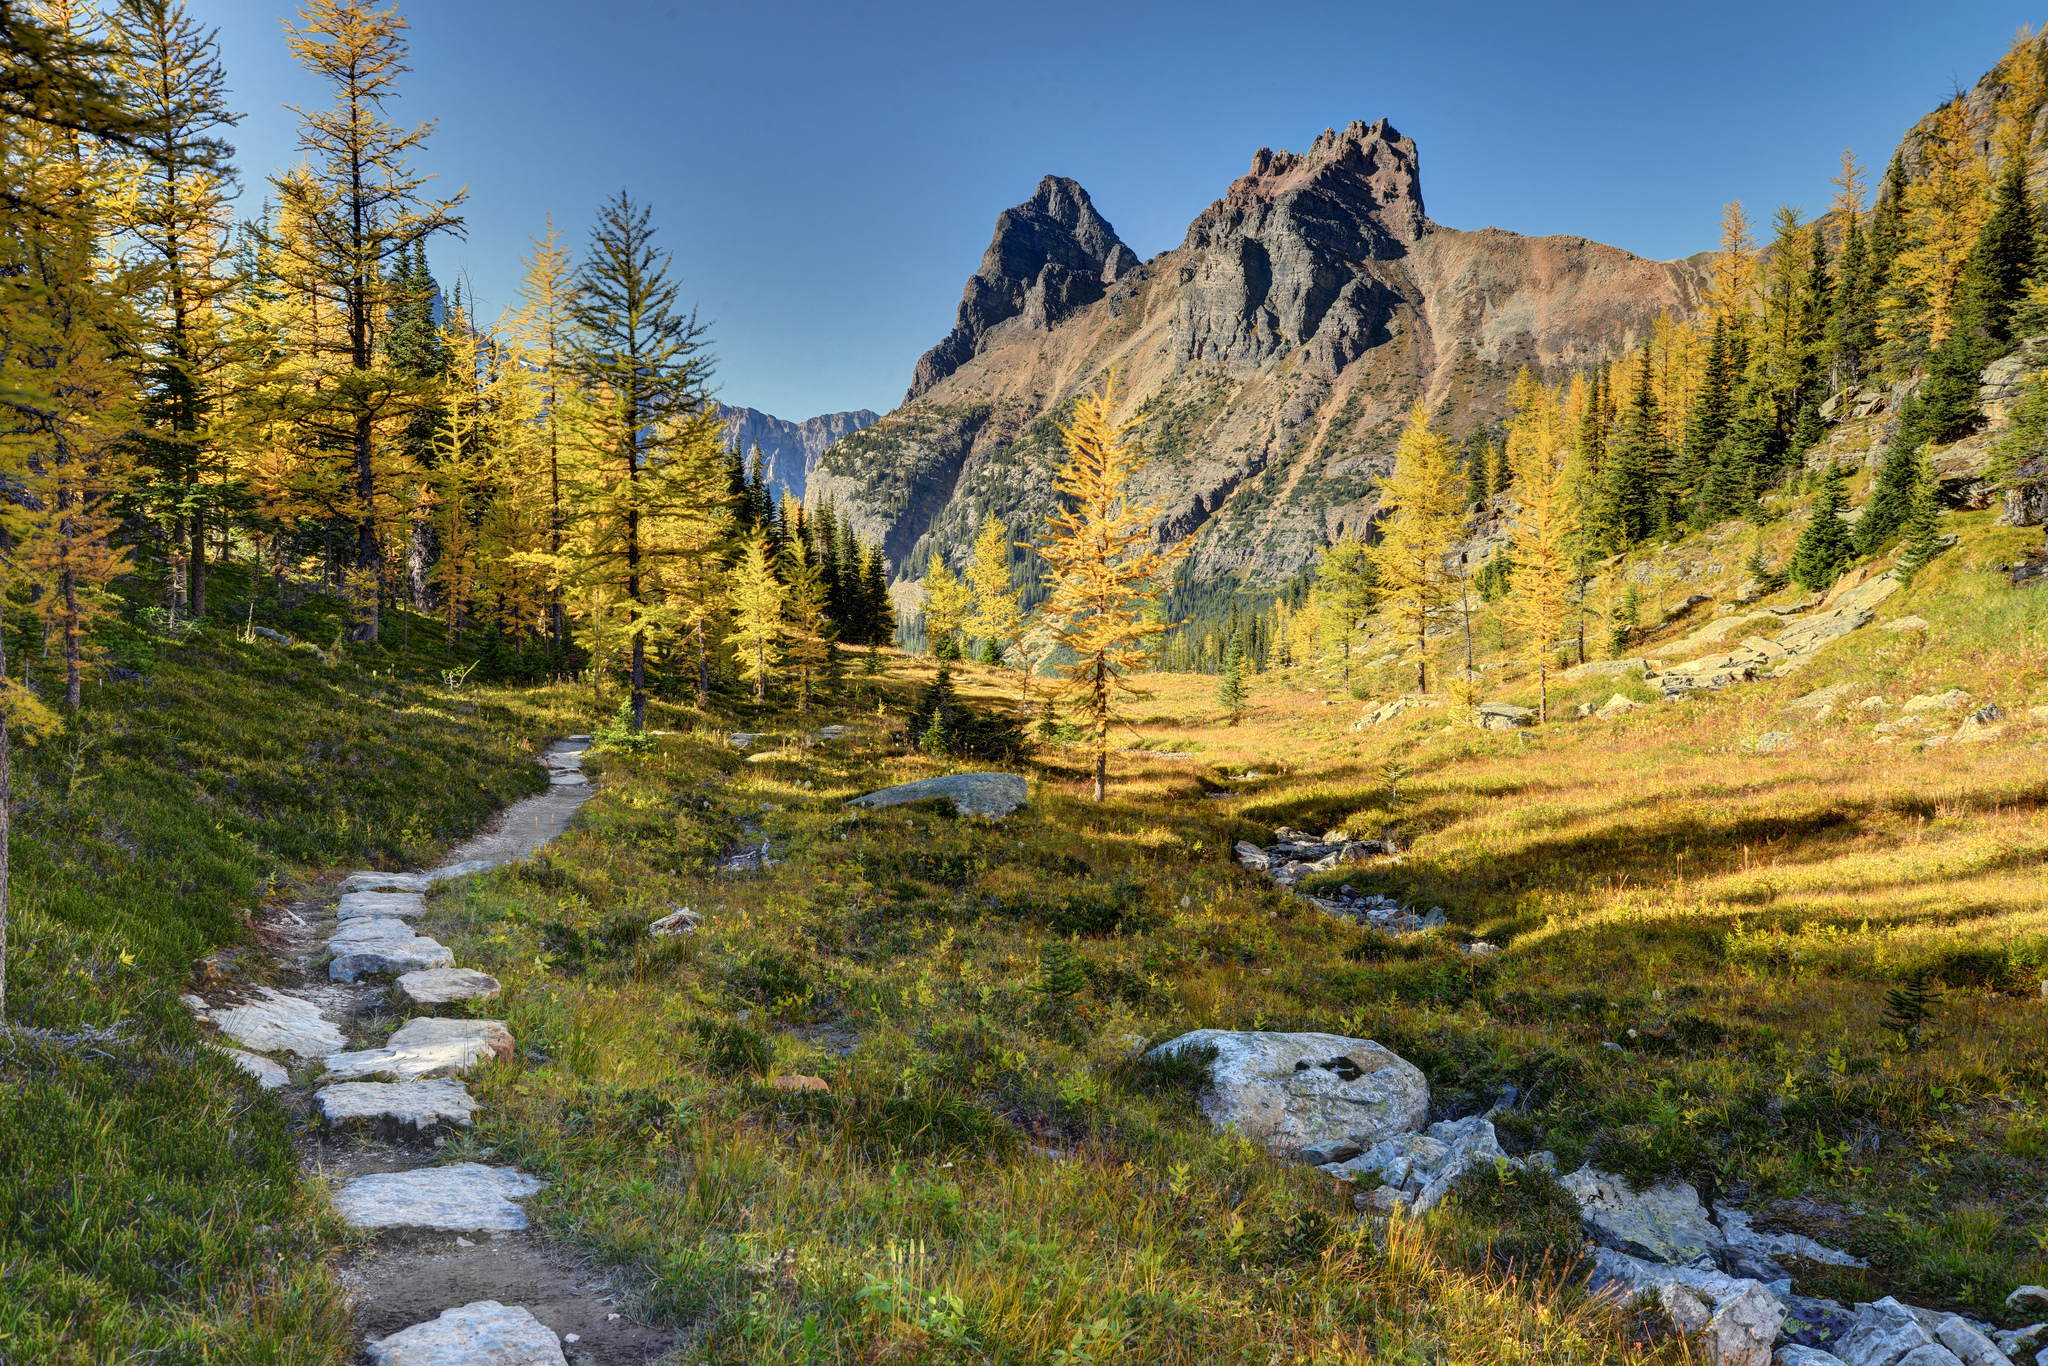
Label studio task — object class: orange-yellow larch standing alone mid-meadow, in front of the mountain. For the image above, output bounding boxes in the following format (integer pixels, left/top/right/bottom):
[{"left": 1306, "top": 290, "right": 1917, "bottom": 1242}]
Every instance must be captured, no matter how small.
[{"left": 1038, "top": 373, "right": 1188, "bottom": 801}]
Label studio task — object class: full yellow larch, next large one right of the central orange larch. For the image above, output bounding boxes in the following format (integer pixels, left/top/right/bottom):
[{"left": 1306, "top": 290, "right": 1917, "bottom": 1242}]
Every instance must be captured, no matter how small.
[{"left": 1368, "top": 403, "right": 1464, "bottom": 692}]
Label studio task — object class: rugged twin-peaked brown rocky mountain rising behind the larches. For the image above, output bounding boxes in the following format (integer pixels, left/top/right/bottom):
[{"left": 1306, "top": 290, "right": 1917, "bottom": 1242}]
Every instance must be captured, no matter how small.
[{"left": 811, "top": 121, "right": 1704, "bottom": 586}]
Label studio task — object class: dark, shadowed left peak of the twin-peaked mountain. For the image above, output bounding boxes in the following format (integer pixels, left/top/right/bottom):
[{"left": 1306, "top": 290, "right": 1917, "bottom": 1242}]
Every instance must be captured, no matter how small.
[{"left": 903, "top": 167, "right": 1139, "bottom": 403}]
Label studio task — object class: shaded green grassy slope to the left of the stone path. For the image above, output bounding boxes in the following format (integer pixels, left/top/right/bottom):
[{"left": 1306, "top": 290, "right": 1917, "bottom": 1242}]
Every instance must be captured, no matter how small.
[{"left": 0, "top": 575, "right": 577, "bottom": 1362}]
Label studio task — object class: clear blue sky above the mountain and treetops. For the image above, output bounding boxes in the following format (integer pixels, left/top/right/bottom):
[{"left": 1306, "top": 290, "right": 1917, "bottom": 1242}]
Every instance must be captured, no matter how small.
[{"left": 207, "top": 0, "right": 2040, "bottom": 418}]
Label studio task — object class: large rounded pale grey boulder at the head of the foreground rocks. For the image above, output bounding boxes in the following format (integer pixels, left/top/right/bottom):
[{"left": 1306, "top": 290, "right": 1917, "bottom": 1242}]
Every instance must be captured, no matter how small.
[{"left": 1147, "top": 1030, "right": 1430, "bottom": 1165}]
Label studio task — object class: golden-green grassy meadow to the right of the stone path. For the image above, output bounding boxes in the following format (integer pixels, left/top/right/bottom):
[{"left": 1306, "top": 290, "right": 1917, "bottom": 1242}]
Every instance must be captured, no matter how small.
[{"left": 395, "top": 497, "right": 2048, "bottom": 1362}]
